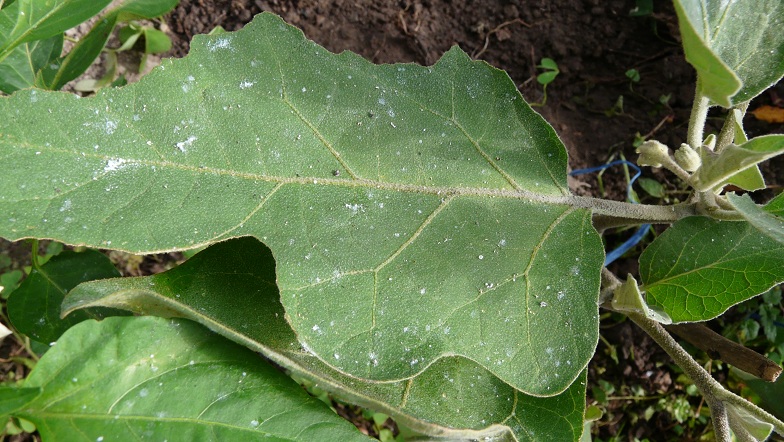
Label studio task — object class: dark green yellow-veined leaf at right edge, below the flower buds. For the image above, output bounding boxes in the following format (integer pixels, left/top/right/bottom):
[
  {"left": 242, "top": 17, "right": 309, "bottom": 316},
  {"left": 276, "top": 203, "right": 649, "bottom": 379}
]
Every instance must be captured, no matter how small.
[{"left": 640, "top": 217, "right": 784, "bottom": 322}]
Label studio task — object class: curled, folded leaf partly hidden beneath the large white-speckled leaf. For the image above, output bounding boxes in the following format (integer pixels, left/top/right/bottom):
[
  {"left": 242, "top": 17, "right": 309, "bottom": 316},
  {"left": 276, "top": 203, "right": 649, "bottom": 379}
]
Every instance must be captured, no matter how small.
[{"left": 58, "top": 238, "right": 585, "bottom": 441}]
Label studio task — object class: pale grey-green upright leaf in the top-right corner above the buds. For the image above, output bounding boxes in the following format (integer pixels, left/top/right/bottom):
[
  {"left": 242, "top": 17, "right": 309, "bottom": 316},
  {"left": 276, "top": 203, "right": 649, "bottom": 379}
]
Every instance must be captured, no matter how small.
[{"left": 675, "top": 0, "right": 784, "bottom": 107}]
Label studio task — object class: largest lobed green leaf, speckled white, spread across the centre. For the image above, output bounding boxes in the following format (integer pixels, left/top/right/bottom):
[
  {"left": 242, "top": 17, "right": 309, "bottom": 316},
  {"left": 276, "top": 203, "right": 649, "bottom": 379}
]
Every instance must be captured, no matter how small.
[{"left": 0, "top": 14, "right": 603, "bottom": 395}]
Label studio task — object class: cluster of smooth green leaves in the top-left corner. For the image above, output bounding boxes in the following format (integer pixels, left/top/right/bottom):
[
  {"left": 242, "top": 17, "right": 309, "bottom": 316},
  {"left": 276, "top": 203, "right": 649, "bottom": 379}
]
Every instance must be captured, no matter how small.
[{"left": 0, "top": 0, "right": 178, "bottom": 93}]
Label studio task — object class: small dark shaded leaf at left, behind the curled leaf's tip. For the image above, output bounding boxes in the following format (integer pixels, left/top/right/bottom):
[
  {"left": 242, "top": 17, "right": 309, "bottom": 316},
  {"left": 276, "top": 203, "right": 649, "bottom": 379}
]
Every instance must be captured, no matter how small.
[{"left": 8, "top": 250, "right": 120, "bottom": 344}]
